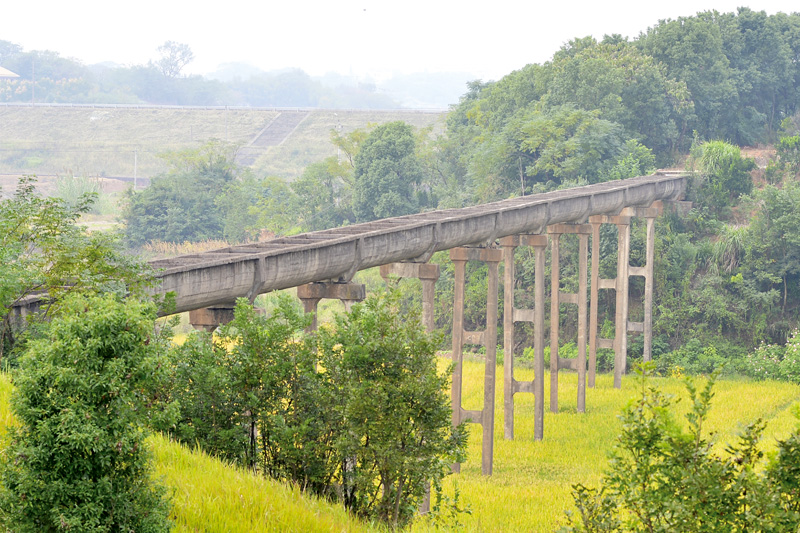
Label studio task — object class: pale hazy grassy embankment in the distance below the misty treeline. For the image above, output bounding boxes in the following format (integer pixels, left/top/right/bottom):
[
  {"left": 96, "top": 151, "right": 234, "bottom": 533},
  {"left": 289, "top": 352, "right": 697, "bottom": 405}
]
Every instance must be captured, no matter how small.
[{"left": 0, "top": 105, "right": 444, "bottom": 179}]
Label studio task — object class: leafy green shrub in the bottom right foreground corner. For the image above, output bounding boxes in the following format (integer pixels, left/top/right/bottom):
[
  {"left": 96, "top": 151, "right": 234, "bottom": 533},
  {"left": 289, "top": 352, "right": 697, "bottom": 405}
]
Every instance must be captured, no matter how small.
[{"left": 563, "top": 366, "right": 800, "bottom": 532}]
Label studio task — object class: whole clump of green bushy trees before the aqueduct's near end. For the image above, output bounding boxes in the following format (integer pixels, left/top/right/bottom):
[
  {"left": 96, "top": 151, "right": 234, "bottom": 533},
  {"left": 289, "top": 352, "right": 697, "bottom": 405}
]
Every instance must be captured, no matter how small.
[{"left": 158, "top": 290, "right": 465, "bottom": 525}]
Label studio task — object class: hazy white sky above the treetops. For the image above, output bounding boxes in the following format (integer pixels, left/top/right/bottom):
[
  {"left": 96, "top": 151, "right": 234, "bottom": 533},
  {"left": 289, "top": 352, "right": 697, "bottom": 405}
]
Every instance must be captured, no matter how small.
[{"left": 0, "top": 0, "right": 800, "bottom": 80}]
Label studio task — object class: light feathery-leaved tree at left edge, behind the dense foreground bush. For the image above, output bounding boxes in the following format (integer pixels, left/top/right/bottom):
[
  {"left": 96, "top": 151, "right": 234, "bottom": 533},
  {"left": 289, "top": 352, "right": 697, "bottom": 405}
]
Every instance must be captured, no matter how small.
[{"left": 0, "top": 177, "right": 150, "bottom": 359}]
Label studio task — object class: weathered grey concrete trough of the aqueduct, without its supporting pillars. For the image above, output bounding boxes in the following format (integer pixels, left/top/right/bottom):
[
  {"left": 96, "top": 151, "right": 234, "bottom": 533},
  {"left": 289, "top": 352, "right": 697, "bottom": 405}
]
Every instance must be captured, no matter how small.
[{"left": 151, "top": 173, "right": 687, "bottom": 312}]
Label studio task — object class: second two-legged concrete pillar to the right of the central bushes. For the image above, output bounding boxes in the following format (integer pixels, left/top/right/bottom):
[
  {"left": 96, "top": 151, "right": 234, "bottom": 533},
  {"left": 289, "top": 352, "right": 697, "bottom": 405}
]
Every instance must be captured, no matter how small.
[{"left": 500, "top": 235, "right": 547, "bottom": 440}]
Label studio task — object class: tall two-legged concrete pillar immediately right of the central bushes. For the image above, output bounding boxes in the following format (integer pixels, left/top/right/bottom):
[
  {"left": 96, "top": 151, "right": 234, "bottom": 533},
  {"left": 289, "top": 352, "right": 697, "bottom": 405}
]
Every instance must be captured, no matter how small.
[{"left": 450, "top": 248, "right": 503, "bottom": 476}]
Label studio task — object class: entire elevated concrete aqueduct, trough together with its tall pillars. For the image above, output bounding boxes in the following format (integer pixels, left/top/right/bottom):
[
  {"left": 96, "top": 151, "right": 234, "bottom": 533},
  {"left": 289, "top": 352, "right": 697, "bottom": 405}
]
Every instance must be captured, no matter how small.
[{"left": 151, "top": 172, "right": 687, "bottom": 475}]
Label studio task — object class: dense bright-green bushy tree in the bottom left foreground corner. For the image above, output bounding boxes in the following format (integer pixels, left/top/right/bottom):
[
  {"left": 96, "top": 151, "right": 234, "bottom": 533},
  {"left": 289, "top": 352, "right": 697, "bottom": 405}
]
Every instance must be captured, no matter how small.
[{"left": 0, "top": 295, "right": 169, "bottom": 532}]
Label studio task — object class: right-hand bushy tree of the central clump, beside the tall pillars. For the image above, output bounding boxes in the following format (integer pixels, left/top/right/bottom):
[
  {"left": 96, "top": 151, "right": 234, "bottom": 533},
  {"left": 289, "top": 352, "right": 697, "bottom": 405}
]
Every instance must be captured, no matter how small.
[{"left": 318, "top": 289, "right": 466, "bottom": 527}]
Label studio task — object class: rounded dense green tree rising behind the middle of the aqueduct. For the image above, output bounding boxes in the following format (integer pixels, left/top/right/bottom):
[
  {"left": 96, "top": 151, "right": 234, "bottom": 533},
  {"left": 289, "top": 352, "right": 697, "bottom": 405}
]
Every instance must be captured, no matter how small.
[{"left": 353, "top": 121, "right": 422, "bottom": 222}]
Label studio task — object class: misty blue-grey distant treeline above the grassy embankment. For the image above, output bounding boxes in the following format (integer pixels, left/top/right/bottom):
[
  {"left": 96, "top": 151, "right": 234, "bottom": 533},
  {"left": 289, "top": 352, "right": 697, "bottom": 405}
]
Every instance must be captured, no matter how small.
[{"left": 0, "top": 40, "right": 401, "bottom": 109}]
